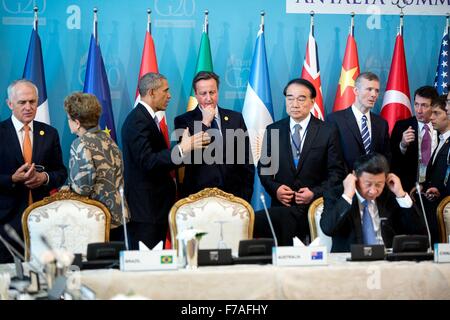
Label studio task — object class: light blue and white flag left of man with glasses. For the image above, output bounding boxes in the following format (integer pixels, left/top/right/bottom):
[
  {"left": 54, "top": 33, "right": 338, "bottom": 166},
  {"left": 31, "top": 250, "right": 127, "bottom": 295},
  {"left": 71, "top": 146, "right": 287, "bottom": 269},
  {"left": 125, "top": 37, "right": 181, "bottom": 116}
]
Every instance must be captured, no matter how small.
[{"left": 242, "top": 25, "right": 274, "bottom": 210}]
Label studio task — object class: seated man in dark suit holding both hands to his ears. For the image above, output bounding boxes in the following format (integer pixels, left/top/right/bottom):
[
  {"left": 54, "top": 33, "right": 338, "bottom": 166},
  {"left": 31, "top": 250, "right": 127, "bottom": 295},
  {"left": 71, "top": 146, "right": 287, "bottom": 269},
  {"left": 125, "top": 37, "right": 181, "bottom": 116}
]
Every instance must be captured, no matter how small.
[{"left": 320, "top": 153, "right": 425, "bottom": 252}]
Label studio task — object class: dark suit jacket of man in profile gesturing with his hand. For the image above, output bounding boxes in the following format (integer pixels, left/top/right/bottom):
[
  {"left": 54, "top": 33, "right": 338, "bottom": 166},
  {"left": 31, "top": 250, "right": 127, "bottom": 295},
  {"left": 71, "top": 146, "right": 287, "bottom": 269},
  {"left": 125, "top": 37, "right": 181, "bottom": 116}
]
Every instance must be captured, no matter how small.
[{"left": 122, "top": 103, "right": 176, "bottom": 224}]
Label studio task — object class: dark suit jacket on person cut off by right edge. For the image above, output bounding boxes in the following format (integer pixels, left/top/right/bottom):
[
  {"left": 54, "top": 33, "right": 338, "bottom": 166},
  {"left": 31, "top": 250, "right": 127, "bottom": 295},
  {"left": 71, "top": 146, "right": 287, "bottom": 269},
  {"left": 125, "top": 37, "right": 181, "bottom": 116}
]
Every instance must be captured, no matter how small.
[{"left": 424, "top": 138, "right": 450, "bottom": 200}]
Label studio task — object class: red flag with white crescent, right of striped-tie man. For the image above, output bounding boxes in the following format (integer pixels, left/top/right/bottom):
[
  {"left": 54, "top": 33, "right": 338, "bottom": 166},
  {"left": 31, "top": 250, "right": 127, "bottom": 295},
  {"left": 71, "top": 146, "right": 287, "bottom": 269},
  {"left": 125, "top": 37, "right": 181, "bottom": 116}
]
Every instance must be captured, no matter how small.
[{"left": 380, "top": 34, "right": 412, "bottom": 134}]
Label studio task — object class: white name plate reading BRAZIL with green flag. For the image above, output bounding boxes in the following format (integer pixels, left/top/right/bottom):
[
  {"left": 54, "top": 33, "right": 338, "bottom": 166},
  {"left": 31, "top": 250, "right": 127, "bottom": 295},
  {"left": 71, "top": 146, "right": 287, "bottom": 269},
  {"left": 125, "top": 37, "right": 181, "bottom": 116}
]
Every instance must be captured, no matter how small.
[{"left": 120, "top": 250, "right": 177, "bottom": 271}]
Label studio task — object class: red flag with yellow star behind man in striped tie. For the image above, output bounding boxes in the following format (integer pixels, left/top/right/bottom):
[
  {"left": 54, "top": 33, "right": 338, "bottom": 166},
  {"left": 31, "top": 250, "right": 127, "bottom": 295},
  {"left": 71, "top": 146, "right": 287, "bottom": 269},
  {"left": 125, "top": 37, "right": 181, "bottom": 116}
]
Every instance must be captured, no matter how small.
[{"left": 333, "top": 34, "right": 360, "bottom": 112}]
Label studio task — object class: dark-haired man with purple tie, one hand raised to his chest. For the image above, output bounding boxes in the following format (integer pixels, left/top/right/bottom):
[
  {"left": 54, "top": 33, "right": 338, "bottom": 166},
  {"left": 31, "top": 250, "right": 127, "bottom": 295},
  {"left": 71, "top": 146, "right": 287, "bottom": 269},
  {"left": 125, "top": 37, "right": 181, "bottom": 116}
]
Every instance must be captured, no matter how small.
[{"left": 391, "top": 86, "right": 438, "bottom": 192}]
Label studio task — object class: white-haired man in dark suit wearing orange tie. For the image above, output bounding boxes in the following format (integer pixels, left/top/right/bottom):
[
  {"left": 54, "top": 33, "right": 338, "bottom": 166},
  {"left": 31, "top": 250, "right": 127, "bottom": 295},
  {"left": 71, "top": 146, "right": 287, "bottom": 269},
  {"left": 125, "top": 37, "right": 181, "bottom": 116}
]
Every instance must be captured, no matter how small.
[{"left": 0, "top": 80, "right": 67, "bottom": 263}]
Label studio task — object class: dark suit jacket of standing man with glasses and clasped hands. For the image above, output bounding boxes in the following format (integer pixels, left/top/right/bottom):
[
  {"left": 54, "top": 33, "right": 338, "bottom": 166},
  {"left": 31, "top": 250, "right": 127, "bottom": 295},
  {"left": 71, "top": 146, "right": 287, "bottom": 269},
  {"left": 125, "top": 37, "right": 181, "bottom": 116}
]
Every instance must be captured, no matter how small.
[{"left": 258, "top": 116, "right": 345, "bottom": 206}]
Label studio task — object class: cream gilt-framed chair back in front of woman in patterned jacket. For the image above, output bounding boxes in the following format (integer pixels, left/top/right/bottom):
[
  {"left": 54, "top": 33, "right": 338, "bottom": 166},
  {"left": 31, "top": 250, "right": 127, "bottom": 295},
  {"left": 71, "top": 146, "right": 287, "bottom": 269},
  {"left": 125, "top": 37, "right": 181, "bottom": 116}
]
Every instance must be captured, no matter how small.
[{"left": 22, "top": 191, "right": 111, "bottom": 260}]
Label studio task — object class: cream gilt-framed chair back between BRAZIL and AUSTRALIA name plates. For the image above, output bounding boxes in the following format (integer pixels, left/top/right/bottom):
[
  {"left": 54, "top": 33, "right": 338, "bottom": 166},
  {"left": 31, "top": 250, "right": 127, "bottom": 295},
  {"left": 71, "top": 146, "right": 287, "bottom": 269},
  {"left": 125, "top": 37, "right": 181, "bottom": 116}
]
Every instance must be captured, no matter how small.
[{"left": 169, "top": 188, "right": 255, "bottom": 255}]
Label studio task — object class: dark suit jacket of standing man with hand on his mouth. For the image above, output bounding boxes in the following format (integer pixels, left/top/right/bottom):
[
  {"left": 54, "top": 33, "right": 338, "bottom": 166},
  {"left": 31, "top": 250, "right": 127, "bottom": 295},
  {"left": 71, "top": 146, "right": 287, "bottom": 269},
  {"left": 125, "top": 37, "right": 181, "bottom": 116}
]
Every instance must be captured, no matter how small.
[{"left": 175, "top": 106, "right": 255, "bottom": 202}]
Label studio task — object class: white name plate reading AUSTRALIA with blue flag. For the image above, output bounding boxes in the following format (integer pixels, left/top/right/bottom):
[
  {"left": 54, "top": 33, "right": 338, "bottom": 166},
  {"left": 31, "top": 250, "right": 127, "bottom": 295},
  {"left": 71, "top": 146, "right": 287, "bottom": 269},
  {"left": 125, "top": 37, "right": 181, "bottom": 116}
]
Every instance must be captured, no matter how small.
[{"left": 272, "top": 246, "right": 328, "bottom": 266}]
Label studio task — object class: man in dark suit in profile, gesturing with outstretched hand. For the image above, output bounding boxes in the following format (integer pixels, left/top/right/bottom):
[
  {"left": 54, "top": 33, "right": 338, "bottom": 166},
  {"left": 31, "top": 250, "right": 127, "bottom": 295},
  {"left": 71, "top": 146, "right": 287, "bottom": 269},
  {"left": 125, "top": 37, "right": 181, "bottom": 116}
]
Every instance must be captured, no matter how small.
[{"left": 122, "top": 73, "right": 209, "bottom": 249}]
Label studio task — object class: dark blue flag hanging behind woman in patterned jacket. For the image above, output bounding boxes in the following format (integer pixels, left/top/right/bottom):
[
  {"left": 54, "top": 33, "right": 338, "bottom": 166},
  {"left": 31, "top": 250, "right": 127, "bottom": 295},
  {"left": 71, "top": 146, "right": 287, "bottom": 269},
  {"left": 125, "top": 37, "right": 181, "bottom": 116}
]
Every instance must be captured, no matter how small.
[{"left": 83, "top": 27, "right": 117, "bottom": 142}]
